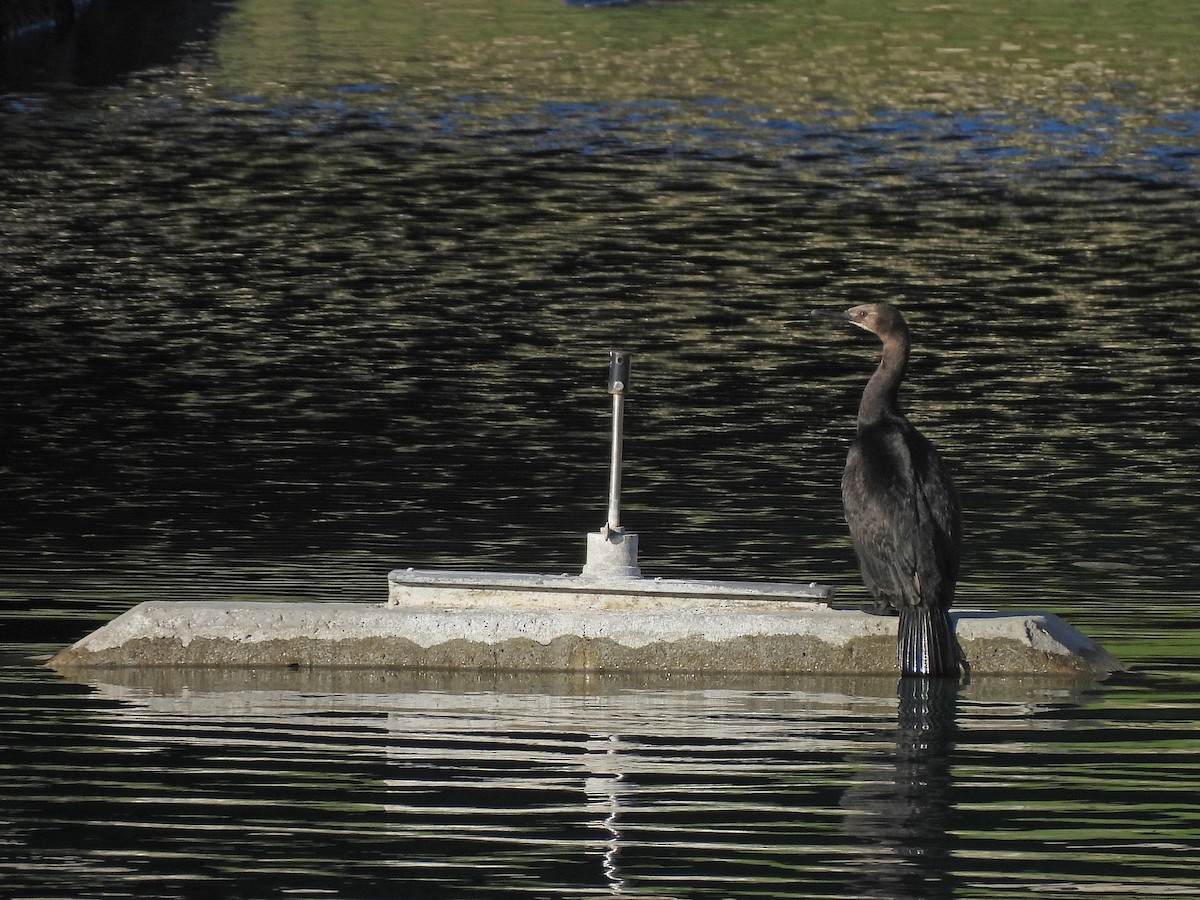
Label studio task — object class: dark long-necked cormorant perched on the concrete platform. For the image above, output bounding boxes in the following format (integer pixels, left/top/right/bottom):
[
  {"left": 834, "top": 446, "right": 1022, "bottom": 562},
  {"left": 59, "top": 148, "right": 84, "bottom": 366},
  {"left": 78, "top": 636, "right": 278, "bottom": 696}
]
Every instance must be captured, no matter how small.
[{"left": 841, "top": 304, "right": 962, "bottom": 676}]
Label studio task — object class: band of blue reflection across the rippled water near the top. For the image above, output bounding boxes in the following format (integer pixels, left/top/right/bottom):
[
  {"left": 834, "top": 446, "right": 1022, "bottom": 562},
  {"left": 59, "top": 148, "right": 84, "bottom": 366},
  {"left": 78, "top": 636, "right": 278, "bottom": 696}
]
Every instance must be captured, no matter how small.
[{"left": 229, "top": 83, "right": 1185, "bottom": 180}]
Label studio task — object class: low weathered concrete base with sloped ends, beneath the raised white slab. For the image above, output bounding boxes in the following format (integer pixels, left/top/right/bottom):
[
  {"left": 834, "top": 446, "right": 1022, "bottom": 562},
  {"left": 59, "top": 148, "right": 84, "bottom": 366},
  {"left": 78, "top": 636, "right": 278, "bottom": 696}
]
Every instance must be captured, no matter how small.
[{"left": 42, "top": 601, "right": 1124, "bottom": 676}]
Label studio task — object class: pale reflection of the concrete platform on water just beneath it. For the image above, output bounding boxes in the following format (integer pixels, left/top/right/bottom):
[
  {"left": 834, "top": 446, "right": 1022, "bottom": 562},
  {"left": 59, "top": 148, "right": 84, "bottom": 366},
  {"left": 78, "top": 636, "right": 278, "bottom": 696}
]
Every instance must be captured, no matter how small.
[{"left": 58, "top": 666, "right": 1102, "bottom": 710}]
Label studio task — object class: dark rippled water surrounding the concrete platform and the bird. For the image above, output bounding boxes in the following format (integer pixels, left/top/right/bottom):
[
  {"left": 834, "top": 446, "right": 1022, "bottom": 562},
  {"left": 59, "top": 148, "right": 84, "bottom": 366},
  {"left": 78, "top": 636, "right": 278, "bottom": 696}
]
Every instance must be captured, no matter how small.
[{"left": 0, "top": 0, "right": 1200, "bottom": 898}]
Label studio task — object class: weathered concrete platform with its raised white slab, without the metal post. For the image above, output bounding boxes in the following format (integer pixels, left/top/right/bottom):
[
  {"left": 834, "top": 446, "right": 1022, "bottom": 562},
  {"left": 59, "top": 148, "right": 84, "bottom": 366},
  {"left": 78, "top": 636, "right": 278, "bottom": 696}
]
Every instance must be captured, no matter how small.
[{"left": 50, "top": 571, "right": 1121, "bottom": 674}]
